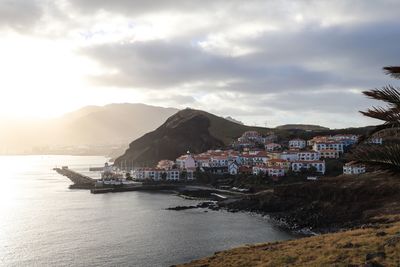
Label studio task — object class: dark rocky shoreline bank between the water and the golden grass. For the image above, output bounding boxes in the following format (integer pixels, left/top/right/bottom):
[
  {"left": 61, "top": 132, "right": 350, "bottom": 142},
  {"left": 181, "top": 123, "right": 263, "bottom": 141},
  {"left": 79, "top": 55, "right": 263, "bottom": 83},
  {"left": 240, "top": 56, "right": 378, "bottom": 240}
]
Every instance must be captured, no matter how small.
[{"left": 169, "top": 174, "right": 400, "bottom": 235}]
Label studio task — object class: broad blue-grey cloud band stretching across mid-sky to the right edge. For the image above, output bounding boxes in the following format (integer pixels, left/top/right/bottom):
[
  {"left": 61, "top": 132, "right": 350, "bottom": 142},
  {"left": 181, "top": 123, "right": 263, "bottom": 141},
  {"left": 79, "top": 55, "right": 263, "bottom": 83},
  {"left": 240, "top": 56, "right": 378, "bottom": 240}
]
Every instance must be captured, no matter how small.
[{"left": 81, "top": 18, "right": 400, "bottom": 93}]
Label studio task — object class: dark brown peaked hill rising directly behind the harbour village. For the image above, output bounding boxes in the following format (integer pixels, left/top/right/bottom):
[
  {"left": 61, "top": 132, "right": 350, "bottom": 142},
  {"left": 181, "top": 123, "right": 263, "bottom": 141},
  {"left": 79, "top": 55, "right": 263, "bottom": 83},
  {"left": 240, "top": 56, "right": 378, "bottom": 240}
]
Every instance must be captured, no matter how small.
[{"left": 115, "top": 109, "right": 270, "bottom": 166}]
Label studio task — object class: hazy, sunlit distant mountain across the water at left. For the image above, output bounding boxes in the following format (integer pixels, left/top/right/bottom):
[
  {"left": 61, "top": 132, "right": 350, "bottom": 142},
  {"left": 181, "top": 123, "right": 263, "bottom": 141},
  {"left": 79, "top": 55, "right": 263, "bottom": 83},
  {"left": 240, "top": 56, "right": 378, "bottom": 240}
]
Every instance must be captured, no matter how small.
[{"left": 0, "top": 103, "right": 178, "bottom": 154}]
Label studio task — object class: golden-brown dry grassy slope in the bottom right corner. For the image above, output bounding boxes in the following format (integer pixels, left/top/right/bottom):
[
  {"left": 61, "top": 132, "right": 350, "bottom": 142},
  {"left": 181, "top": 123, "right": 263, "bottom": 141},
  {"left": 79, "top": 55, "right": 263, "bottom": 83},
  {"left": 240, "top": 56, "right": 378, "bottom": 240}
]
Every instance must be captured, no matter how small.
[{"left": 178, "top": 216, "right": 400, "bottom": 267}]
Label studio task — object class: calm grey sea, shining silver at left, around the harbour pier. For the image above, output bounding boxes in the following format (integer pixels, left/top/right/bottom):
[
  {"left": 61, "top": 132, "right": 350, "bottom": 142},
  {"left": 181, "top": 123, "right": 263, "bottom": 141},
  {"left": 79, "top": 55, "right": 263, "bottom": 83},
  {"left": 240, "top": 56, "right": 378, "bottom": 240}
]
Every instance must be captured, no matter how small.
[{"left": 0, "top": 156, "right": 292, "bottom": 266}]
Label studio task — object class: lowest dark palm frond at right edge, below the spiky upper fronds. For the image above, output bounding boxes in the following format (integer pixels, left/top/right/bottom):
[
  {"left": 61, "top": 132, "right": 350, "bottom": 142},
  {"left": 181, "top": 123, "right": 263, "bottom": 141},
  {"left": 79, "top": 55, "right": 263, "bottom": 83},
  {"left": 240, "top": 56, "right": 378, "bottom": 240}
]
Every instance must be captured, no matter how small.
[{"left": 348, "top": 144, "right": 400, "bottom": 172}]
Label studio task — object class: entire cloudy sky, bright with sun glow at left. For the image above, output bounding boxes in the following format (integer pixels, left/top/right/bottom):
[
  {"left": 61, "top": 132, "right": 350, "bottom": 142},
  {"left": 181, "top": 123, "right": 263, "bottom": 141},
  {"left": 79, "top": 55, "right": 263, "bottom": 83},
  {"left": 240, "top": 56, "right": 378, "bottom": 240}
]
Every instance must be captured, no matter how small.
[{"left": 0, "top": 0, "right": 400, "bottom": 128}]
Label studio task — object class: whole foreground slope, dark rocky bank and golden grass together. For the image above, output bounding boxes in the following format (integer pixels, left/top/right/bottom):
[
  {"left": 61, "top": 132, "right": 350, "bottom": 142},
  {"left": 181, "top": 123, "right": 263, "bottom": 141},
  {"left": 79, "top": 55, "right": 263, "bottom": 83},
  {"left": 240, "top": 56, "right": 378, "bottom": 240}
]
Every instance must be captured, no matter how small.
[{"left": 182, "top": 172, "right": 400, "bottom": 267}]
